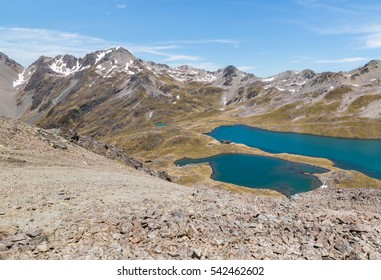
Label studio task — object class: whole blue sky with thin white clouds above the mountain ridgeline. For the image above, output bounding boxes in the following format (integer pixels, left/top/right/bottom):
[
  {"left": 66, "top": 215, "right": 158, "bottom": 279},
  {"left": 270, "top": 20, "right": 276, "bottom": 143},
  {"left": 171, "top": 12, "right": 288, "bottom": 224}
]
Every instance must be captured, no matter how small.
[{"left": 0, "top": 0, "right": 381, "bottom": 77}]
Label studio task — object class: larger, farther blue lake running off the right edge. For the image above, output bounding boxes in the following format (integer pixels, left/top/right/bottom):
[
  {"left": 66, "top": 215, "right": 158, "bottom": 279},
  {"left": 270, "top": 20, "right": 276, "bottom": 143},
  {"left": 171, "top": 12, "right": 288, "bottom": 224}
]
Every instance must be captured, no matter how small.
[{"left": 208, "top": 125, "right": 381, "bottom": 179}]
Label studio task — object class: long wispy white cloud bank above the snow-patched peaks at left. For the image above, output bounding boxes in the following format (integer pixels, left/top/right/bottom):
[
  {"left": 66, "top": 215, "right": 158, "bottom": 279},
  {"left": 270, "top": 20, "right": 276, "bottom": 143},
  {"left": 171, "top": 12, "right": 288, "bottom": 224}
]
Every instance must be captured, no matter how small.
[{"left": 0, "top": 26, "right": 229, "bottom": 70}]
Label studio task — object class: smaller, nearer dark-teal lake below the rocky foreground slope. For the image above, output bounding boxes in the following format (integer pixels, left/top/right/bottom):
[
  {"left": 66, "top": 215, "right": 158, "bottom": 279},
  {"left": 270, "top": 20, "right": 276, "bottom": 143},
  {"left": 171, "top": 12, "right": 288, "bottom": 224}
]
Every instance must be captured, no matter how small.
[{"left": 175, "top": 154, "right": 328, "bottom": 195}]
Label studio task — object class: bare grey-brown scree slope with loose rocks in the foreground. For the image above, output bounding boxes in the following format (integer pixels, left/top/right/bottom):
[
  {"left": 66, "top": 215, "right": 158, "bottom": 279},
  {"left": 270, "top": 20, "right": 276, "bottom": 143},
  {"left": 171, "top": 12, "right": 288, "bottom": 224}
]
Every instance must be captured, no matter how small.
[{"left": 0, "top": 118, "right": 381, "bottom": 259}]
